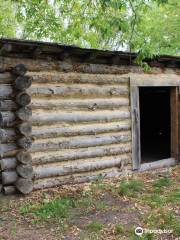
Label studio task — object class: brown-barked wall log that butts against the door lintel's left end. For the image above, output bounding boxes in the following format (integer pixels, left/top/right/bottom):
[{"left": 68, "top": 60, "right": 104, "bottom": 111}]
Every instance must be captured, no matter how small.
[{"left": 30, "top": 72, "right": 129, "bottom": 85}]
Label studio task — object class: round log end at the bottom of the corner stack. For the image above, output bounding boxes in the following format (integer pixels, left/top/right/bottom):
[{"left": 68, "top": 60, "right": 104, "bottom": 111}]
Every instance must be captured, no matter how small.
[{"left": 15, "top": 178, "right": 33, "bottom": 194}]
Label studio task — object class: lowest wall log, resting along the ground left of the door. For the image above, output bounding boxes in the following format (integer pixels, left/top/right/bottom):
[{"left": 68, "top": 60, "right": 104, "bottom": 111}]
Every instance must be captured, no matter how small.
[{"left": 34, "top": 168, "right": 122, "bottom": 190}]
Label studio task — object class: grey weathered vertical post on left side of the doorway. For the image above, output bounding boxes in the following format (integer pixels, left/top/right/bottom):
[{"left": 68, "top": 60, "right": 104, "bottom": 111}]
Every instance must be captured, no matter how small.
[{"left": 130, "top": 86, "right": 141, "bottom": 170}]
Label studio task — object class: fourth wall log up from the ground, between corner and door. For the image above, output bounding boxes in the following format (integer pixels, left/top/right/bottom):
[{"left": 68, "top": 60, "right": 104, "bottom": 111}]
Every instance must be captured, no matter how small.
[{"left": 31, "top": 131, "right": 131, "bottom": 152}]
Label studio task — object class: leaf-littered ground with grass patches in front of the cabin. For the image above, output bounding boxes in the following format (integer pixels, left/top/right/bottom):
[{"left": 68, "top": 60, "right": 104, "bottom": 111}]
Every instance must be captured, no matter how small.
[{"left": 0, "top": 166, "right": 180, "bottom": 240}]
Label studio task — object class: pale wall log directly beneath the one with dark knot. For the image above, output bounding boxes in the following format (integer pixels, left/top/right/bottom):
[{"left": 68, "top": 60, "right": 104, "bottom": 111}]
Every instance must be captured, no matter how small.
[{"left": 32, "top": 109, "right": 130, "bottom": 125}]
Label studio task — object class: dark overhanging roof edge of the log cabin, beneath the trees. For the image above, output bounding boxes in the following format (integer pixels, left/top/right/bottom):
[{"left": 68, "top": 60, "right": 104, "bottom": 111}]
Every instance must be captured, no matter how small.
[{"left": 0, "top": 38, "right": 180, "bottom": 68}]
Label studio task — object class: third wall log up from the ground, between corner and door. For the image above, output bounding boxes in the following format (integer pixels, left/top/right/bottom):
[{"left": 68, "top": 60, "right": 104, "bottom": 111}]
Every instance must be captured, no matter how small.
[{"left": 32, "top": 143, "right": 131, "bottom": 165}]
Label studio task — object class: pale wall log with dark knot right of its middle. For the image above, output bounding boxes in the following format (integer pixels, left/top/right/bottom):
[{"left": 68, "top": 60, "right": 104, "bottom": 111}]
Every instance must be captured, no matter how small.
[{"left": 31, "top": 97, "right": 129, "bottom": 110}]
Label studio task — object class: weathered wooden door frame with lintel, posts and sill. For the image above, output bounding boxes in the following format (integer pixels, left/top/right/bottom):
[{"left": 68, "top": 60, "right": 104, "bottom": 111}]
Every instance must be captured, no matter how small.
[{"left": 130, "top": 74, "right": 180, "bottom": 171}]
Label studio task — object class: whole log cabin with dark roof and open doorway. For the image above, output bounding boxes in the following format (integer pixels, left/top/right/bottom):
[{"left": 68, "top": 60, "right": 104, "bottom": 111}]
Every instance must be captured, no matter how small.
[{"left": 0, "top": 39, "right": 180, "bottom": 194}]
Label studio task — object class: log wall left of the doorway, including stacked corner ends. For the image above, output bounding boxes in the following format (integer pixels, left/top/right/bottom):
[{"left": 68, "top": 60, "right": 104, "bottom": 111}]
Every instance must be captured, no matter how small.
[{"left": 0, "top": 57, "right": 179, "bottom": 194}]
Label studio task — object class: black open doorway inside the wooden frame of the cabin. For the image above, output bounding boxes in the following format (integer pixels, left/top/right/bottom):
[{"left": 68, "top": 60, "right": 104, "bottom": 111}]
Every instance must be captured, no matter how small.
[{"left": 139, "top": 87, "right": 171, "bottom": 163}]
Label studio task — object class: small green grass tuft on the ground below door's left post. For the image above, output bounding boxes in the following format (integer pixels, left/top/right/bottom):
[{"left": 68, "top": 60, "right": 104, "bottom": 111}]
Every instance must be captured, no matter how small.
[{"left": 119, "top": 179, "right": 144, "bottom": 196}]
